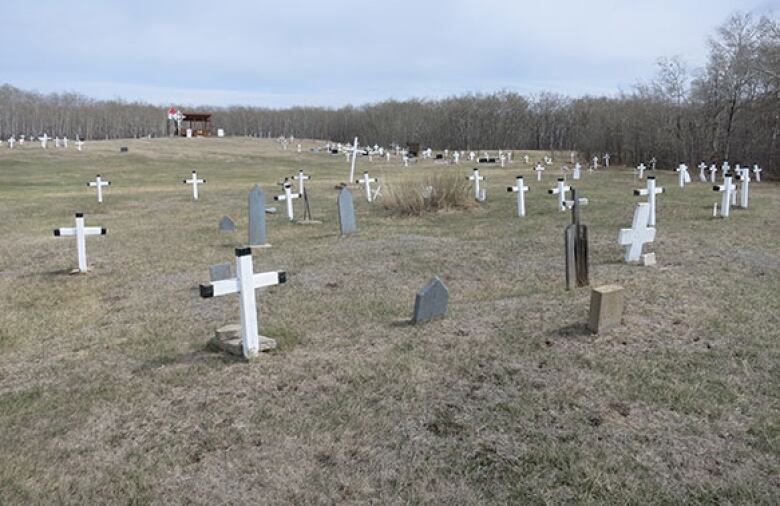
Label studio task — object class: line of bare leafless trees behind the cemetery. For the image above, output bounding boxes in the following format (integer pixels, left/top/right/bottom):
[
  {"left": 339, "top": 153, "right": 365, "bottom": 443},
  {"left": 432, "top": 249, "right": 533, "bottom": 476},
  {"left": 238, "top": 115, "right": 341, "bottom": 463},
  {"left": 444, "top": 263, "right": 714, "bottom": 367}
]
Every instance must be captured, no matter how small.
[{"left": 0, "top": 14, "right": 780, "bottom": 177}]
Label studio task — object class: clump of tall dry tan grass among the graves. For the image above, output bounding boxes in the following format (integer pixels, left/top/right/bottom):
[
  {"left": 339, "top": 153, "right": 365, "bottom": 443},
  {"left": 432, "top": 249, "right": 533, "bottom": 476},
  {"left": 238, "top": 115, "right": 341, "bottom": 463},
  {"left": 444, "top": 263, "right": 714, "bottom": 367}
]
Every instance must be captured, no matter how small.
[{"left": 382, "top": 171, "right": 475, "bottom": 216}]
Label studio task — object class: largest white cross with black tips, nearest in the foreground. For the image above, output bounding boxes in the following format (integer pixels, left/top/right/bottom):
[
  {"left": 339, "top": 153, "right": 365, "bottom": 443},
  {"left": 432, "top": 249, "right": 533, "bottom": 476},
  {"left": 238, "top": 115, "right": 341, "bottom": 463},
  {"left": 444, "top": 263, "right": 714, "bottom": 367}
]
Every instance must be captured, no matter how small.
[{"left": 200, "top": 248, "right": 287, "bottom": 358}]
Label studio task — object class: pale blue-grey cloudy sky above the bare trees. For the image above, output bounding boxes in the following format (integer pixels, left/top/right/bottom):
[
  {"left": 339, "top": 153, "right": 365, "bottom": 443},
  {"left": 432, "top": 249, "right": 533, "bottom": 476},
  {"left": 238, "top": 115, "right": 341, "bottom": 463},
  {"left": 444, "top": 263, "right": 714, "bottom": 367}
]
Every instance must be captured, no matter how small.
[{"left": 0, "top": 0, "right": 780, "bottom": 107}]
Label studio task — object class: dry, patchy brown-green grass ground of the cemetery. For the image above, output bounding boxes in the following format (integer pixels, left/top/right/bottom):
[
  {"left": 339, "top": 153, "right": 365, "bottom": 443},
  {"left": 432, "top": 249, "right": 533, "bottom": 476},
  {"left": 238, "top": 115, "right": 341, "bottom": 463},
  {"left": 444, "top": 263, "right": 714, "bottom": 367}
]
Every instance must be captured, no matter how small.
[{"left": 0, "top": 138, "right": 780, "bottom": 504}]
